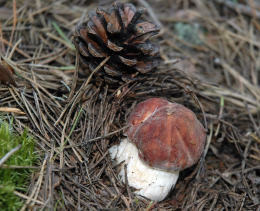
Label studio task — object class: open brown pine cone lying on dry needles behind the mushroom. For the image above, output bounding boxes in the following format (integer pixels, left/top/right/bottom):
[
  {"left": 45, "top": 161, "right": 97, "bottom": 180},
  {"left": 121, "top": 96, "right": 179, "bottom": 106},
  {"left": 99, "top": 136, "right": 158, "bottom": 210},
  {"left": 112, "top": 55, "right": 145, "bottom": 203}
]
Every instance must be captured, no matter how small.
[{"left": 74, "top": 3, "right": 159, "bottom": 86}]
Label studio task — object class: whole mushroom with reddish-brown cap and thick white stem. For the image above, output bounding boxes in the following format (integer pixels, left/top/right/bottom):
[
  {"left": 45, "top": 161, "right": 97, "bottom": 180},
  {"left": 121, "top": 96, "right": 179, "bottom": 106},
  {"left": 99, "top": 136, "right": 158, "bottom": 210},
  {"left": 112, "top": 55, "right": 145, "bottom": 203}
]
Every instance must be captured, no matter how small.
[{"left": 109, "top": 98, "right": 206, "bottom": 201}]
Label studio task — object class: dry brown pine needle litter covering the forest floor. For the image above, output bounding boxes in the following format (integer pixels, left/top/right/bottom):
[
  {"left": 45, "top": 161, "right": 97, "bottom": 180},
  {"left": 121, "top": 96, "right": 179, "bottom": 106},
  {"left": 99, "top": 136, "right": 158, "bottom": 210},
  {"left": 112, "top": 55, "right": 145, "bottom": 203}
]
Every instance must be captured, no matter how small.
[{"left": 0, "top": 0, "right": 260, "bottom": 210}]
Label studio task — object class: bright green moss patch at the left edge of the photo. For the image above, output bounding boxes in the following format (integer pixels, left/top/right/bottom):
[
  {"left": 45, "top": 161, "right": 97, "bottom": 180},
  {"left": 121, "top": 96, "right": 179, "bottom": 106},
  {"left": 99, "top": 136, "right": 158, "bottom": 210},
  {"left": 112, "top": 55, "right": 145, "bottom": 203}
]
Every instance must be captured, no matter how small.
[{"left": 0, "top": 122, "right": 37, "bottom": 210}]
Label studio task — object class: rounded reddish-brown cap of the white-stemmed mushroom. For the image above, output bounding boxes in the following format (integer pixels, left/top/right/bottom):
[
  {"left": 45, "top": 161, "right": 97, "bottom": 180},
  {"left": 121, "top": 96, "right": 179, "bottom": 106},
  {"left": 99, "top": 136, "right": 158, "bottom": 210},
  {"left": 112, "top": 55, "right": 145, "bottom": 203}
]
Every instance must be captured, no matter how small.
[{"left": 126, "top": 98, "right": 206, "bottom": 170}]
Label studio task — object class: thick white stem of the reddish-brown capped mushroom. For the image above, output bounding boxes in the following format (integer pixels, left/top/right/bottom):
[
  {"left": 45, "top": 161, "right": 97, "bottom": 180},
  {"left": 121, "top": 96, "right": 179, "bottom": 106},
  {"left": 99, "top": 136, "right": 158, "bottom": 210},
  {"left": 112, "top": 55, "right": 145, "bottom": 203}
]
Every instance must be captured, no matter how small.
[{"left": 109, "top": 138, "right": 179, "bottom": 201}]
